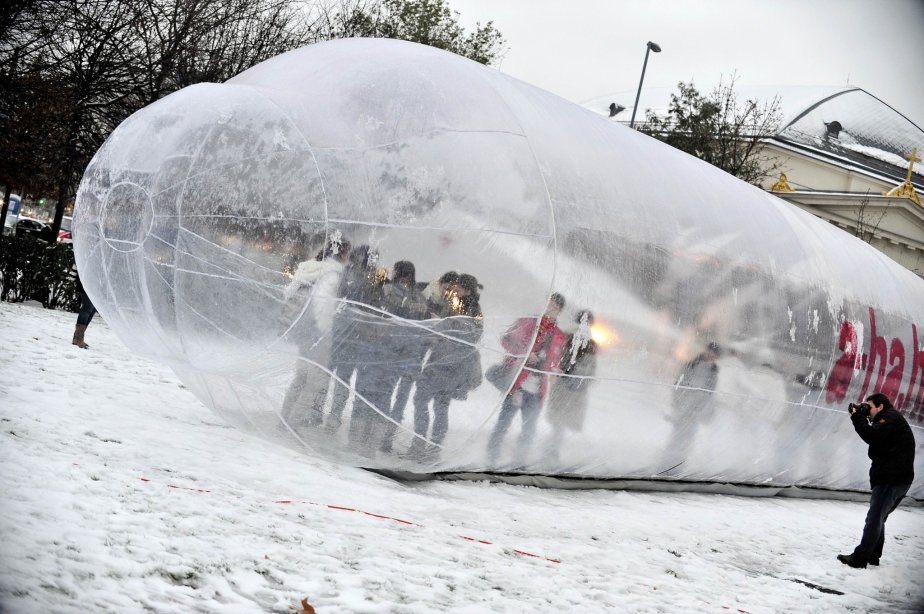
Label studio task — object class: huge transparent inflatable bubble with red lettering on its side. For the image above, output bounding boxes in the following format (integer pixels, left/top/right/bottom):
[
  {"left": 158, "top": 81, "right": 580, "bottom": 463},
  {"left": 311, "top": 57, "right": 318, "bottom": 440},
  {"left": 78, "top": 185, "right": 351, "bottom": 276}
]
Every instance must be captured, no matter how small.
[{"left": 74, "top": 39, "right": 924, "bottom": 497}]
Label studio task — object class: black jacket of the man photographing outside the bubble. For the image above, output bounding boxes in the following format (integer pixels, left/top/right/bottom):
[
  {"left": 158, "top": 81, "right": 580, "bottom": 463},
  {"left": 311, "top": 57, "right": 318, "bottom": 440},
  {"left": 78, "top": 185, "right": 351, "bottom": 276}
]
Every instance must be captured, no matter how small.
[{"left": 850, "top": 407, "right": 915, "bottom": 486}]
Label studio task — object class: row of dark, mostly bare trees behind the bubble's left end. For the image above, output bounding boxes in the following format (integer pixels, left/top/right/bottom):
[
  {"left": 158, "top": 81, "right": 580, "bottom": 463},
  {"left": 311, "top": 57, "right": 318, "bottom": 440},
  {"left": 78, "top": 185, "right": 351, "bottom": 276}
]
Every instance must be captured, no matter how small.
[{"left": 0, "top": 0, "right": 504, "bottom": 236}]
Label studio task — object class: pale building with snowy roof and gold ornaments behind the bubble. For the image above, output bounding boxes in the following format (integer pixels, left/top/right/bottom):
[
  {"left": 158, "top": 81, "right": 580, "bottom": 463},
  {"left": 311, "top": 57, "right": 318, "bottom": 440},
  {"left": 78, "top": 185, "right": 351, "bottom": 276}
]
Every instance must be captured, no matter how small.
[{"left": 763, "top": 87, "right": 924, "bottom": 277}]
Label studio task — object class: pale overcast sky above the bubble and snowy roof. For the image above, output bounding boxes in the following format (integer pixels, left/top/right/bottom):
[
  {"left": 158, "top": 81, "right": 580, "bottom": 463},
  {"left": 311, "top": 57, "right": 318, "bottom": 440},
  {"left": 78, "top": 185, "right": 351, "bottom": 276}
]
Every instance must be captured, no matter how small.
[{"left": 449, "top": 0, "right": 924, "bottom": 129}]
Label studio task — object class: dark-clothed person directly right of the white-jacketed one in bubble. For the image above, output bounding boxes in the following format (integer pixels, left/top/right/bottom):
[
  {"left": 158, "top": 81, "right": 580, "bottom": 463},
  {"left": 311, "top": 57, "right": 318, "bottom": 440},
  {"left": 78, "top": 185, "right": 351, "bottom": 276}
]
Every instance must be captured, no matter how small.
[{"left": 312, "top": 245, "right": 383, "bottom": 436}]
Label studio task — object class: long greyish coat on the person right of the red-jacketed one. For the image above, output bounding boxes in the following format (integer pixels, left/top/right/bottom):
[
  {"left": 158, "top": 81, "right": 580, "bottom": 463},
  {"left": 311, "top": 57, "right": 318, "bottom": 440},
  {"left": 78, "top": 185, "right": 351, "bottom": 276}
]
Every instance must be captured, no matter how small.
[{"left": 545, "top": 335, "right": 597, "bottom": 431}]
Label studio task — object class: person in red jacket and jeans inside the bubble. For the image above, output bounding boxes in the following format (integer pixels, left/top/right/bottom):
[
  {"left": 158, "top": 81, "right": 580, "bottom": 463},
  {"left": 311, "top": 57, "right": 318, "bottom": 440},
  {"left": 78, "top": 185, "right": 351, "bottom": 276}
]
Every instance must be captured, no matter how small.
[{"left": 488, "top": 292, "right": 567, "bottom": 467}]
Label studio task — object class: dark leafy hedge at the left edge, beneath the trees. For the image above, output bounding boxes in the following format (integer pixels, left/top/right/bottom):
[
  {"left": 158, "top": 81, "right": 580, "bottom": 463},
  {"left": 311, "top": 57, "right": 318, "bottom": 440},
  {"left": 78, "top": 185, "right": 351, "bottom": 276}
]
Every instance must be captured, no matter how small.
[{"left": 0, "top": 236, "right": 80, "bottom": 312}]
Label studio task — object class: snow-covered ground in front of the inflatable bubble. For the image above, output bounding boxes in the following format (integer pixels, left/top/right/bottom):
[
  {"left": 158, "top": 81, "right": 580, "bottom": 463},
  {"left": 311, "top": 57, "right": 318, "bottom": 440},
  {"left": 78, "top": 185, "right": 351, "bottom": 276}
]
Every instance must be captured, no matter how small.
[{"left": 0, "top": 303, "right": 924, "bottom": 614}]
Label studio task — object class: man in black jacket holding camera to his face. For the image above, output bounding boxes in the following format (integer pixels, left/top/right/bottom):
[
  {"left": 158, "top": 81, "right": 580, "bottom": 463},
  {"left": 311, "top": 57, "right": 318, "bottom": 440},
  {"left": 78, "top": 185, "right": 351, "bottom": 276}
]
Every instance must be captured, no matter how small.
[{"left": 837, "top": 392, "right": 915, "bottom": 568}]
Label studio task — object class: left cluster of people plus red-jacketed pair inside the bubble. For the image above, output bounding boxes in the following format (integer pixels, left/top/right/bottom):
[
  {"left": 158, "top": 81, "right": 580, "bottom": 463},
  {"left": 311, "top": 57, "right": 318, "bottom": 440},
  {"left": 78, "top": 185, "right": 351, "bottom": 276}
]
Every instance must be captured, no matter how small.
[{"left": 281, "top": 232, "right": 598, "bottom": 463}]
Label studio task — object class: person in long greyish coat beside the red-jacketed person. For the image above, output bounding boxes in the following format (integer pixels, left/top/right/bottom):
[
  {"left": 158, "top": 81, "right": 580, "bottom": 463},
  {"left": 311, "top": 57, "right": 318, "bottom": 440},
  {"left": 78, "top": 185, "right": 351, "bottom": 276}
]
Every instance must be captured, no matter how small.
[{"left": 545, "top": 309, "right": 598, "bottom": 466}]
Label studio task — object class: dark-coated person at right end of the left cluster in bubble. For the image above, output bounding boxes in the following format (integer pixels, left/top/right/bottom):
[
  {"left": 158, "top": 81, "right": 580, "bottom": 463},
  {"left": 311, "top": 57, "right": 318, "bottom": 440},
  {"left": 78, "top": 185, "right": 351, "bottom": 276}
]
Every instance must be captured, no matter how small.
[{"left": 406, "top": 274, "right": 484, "bottom": 460}]
